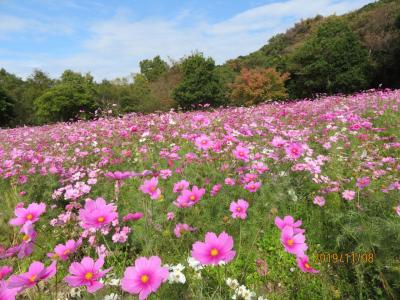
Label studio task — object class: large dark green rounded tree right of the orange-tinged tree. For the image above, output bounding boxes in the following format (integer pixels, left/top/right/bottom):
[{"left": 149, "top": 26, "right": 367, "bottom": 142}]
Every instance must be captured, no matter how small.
[{"left": 289, "top": 17, "right": 371, "bottom": 97}]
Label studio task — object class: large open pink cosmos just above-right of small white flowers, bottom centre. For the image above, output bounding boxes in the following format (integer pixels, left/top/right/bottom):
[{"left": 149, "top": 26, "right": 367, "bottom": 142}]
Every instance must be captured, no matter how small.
[{"left": 192, "top": 232, "right": 236, "bottom": 265}]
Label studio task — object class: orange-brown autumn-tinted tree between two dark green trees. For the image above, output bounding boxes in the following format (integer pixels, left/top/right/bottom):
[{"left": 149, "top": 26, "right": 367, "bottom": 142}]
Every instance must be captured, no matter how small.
[{"left": 231, "top": 68, "right": 289, "bottom": 106}]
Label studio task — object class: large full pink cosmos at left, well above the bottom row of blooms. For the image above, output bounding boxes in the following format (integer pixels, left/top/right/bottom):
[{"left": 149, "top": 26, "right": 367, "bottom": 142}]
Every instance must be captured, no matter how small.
[{"left": 79, "top": 198, "right": 118, "bottom": 229}]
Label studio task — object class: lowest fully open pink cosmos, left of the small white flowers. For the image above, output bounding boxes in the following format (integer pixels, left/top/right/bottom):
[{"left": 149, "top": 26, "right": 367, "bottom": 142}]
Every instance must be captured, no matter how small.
[{"left": 121, "top": 256, "right": 168, "bottom": 300}]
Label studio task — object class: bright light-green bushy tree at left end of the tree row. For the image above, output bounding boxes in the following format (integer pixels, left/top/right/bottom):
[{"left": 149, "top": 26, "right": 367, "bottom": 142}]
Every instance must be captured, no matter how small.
[{"left": 34, "top": 70, "right": 96, "bottom": 122}]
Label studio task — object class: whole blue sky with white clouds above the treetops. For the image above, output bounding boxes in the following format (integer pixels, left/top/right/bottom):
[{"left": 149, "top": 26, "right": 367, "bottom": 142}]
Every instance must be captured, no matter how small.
[{"left": 0, "top": 0, "right": 373, "bottom": 80}]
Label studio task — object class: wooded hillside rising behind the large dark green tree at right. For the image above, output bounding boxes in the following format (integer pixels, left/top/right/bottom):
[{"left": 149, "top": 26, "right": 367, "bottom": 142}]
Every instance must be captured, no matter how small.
[{"left": 226, "top": 0, "right": 400, "bottom": 87}]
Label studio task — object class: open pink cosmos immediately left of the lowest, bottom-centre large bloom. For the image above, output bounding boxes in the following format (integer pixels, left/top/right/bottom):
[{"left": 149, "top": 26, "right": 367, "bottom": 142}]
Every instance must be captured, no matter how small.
[{"left": 64, "top": 256, "right": 111, "bottom": 293}]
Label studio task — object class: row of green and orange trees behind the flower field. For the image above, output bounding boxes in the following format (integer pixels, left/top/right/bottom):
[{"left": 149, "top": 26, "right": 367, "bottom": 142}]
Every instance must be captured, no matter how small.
[{"left": 0, "top": 14, "right": 400, "bottom": 127}]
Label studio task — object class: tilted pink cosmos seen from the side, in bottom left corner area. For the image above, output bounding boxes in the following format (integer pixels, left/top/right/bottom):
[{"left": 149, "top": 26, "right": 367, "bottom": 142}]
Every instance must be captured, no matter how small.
[{"left": 8, "top": 261, "right": 57, "bottom": 289}]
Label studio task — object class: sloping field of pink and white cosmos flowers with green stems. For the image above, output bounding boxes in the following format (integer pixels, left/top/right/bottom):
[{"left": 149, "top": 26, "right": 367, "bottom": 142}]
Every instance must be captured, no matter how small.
[{"left": 0, "top": 90, "right": 400, "bottom": 300}]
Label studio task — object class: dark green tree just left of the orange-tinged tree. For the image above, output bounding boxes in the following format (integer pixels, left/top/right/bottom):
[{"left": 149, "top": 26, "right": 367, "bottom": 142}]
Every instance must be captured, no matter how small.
[{"left": 173, "top": 53, "right": 225, "bottom": 109}]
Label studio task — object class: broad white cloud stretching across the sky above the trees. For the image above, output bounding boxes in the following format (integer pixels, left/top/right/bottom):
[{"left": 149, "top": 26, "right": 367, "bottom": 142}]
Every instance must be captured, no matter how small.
[{"left": 0, "top": 0, "right": 371, "bottom": 80}]
